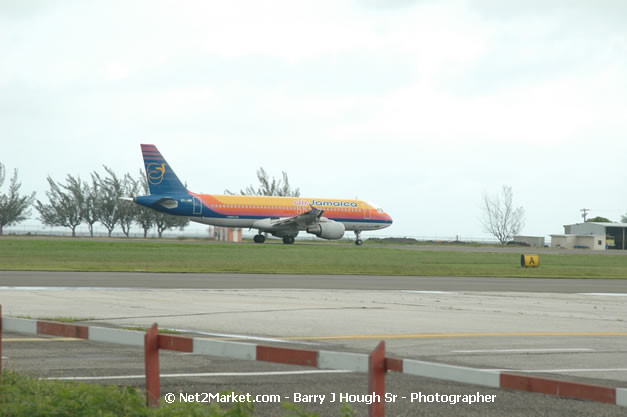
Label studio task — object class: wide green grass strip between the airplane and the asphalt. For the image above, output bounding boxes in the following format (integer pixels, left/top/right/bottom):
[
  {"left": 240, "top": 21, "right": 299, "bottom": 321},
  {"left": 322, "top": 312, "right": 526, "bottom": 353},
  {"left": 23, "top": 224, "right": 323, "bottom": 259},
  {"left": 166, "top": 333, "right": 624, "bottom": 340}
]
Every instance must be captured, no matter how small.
[{"left": 0, "top": 239, "right": 627, "bottom": 278}]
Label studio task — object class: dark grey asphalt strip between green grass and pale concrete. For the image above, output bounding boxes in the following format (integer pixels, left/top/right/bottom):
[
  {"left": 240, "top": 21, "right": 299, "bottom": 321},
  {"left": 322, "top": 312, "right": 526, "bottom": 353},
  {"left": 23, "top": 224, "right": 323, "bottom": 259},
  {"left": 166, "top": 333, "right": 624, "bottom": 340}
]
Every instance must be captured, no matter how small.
[{"left": 0, "top": 271, "right": 627, "bottom": 294}]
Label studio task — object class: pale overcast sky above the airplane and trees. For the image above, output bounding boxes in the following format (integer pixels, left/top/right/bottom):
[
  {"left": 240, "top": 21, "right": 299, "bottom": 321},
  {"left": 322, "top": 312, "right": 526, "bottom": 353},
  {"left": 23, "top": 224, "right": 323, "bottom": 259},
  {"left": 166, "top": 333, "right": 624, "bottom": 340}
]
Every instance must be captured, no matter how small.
[{"left": 0, "top": 0, "right": 627, "bottom": 238}]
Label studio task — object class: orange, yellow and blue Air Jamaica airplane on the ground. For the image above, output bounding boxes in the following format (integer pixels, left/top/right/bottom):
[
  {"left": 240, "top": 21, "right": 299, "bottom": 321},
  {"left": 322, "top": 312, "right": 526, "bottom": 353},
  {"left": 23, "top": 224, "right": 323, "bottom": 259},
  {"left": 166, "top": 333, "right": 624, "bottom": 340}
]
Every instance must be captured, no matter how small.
[{"left": 133, "top": 145, "right": 392, "bottom": 245}]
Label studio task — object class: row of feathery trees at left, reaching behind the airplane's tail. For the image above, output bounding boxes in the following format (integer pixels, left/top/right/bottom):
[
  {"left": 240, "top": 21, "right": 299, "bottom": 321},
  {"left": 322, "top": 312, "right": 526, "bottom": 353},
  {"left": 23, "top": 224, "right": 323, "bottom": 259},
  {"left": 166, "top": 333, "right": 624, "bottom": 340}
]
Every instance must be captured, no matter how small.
[{"left": 0, "top": 163, "right": 189, "bottom": 238}]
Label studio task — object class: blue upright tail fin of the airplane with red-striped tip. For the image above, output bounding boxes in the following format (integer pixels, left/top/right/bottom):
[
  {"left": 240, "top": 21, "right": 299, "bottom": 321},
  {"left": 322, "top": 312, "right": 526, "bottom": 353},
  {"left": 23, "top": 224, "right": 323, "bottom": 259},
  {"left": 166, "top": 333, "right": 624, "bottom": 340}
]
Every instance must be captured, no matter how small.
[{"left": 141, "top": 145, "right": 188, "bottom": 194}]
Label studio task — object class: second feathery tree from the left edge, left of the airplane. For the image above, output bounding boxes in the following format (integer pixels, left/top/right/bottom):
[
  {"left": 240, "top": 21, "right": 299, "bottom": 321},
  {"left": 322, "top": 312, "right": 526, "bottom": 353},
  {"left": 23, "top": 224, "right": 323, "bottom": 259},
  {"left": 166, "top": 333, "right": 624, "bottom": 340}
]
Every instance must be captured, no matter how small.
[{"left": 37, "top": 175, "right": 83, "bottom": 237}]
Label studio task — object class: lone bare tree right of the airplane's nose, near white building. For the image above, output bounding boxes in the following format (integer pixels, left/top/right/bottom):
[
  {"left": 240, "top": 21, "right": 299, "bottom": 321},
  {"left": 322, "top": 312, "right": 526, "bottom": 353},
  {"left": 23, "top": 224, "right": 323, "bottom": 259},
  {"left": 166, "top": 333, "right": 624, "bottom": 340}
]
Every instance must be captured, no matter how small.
[{"left": 481, "top": 185, "right": 525, "bottom": 245}]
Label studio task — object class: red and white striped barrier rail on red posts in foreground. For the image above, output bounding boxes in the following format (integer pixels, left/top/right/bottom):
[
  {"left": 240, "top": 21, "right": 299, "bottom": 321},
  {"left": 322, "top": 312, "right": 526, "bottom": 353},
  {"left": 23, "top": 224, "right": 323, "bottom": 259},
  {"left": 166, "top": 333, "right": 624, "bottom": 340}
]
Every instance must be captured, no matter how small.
[{"left": 0, "top": 312, "right": 627, "bottom": 417}]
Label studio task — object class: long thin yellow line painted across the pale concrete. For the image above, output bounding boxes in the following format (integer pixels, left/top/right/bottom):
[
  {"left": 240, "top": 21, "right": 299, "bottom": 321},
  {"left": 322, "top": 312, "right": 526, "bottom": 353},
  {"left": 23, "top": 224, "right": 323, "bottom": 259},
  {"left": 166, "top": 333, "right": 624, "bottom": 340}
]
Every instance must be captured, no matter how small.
[{"left": 281, "top": 332, "right": 627, "bottom": 340}]
